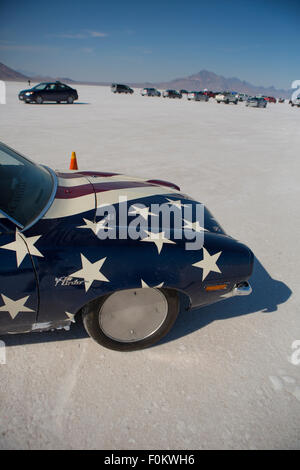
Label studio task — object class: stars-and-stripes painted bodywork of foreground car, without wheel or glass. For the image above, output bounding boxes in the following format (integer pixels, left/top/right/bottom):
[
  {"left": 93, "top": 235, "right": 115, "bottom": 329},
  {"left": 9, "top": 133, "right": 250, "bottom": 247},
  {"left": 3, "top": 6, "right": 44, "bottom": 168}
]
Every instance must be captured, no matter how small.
[{"left": 0, "top": 165, "right": 253, "bottom": 334}]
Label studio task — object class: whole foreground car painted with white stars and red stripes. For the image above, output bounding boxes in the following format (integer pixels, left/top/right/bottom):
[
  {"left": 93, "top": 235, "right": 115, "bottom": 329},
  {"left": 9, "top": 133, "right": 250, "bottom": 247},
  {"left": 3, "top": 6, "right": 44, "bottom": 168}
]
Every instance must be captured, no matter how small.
[{"left": 0, "top": 143, "right": 253, "bottom": 351}]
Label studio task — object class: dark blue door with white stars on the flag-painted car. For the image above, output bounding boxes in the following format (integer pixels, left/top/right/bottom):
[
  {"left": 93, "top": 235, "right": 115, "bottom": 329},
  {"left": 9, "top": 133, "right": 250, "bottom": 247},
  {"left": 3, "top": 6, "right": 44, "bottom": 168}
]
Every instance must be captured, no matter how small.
[{"left": 0, "top": 217, "right": 38, "bottom": 334}]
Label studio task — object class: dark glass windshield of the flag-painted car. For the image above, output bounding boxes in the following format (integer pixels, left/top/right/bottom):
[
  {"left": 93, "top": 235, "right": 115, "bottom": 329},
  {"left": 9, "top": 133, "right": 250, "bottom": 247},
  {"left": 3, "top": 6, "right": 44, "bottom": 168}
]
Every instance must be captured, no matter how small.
[{"left": 0, "top": 143, "right": 54, "bottom": 228}]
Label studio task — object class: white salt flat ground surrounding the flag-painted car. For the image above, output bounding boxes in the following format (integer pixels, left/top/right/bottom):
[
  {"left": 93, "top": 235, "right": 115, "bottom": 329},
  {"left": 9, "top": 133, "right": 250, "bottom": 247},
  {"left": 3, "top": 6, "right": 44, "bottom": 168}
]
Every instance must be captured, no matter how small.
[{"left": 0, "top": 83, "right": 300, "bottom": 449}]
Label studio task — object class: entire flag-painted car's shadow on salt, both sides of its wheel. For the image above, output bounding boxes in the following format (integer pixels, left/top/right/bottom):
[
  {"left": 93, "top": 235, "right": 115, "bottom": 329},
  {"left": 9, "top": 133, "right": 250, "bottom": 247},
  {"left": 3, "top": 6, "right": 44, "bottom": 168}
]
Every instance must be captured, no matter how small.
[{"left": 2, "top": 258, "right": 292, "bottom": 347}]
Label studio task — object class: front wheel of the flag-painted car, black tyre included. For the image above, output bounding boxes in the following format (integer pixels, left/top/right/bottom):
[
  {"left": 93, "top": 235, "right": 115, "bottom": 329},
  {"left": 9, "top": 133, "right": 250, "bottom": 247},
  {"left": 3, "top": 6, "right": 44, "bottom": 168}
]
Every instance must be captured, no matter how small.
[{"left": 82, "top": 288, "right": 179, "bottom": 351}]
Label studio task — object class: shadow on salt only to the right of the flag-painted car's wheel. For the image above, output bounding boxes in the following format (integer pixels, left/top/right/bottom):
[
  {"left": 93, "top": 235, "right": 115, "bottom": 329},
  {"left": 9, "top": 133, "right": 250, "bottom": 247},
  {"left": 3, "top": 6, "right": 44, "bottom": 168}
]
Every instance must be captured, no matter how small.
[{"left": 158, "top": 258, "right": 292, "bottom": 347}]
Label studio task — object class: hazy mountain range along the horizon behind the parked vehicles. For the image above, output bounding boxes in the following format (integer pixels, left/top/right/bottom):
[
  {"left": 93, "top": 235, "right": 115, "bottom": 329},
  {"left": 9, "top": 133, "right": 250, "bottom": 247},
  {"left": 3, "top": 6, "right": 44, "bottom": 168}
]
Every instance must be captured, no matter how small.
[{"left": 0, "top": 62, "right": 291, "bottom": 98}]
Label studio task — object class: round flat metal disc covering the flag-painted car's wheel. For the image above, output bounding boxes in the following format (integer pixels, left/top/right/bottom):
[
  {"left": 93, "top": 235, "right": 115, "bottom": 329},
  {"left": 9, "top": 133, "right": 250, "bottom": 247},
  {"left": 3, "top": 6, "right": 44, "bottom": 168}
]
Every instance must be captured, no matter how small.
[{"left": 99, "top": 288, "right": 168, "bottom": 343}]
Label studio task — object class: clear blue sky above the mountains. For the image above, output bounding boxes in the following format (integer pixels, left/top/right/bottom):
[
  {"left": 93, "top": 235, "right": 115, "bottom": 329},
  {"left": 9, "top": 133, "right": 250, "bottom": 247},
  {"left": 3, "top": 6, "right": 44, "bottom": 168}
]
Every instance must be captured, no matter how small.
[{"left": 0, "top": 0, "right": 300, "bottom": 88}]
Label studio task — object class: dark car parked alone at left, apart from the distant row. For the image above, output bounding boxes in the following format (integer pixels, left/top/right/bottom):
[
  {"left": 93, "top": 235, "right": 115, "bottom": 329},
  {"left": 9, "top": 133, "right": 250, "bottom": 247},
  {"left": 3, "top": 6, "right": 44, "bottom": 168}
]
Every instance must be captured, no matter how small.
[{"left": 19, "top": 82, "right": 78, "bottom": 104}]
